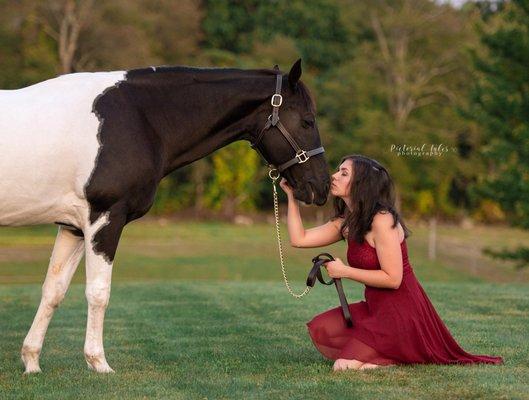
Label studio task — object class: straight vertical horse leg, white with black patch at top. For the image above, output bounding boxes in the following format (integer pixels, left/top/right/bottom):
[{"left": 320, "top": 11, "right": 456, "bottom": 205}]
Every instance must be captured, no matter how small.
[{"left": 84, "top": 211, "right": 125, "bottom": 372}]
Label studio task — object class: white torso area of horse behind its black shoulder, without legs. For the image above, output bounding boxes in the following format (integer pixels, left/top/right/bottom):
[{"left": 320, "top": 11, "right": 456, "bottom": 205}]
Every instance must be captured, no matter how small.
[{"left": 0, "top": 71, "right": 125, "bottom": 225}]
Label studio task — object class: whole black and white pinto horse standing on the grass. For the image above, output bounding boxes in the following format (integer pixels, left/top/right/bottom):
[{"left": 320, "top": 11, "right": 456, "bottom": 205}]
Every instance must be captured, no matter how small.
[{"left": 0, "top": 60, "right": 329, "bottom": 373}]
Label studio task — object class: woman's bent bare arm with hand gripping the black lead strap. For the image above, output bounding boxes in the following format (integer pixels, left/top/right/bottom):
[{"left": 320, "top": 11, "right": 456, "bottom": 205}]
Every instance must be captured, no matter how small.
[{"left": 346, "top": 213, "right": 403, "bottom": 289}]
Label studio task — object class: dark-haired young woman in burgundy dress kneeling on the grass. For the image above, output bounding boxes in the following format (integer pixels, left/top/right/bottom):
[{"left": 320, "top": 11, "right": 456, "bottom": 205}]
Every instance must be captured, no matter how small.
[{"left": 280, "top": 155, "right": 503, "bottom": 371}]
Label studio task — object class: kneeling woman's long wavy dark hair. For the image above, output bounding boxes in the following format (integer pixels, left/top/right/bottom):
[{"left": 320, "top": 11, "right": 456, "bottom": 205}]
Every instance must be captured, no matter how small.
[{"left": 331, "top": 154, "right": 411, "bottom": 243}]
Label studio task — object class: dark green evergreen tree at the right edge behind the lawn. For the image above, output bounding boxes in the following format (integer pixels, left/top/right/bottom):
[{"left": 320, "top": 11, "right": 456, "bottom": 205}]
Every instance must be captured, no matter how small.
[{"left": 467, "top": 0, "right": 529, "bottom": 265}]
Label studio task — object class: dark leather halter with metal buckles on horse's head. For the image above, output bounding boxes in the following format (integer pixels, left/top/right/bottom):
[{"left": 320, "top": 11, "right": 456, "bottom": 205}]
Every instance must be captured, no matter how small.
[{"left": 250, "top": 65, "right": 325, "bottom": 172}]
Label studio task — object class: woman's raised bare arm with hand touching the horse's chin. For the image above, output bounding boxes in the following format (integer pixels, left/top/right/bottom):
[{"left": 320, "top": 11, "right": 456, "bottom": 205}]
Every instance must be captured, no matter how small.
[{"left": 280, "top": 181, "right": 342, "bottom": 248}]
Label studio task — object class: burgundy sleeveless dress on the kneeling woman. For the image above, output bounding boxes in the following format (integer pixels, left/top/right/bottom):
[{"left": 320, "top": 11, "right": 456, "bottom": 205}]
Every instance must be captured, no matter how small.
[{"left": 307, "top": 239, "right": 503, "bottom": 365}]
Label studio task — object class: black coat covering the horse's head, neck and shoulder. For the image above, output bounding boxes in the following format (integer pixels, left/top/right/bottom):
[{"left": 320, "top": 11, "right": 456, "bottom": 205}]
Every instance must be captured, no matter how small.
[{"left": 85, "top": 66, "right": 329, "bottom": 261}]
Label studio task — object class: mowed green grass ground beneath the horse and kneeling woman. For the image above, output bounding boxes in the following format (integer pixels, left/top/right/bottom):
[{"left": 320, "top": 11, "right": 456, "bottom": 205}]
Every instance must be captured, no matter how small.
[{"left": 0, "top": 220, "right": 529, "bottom": 399}]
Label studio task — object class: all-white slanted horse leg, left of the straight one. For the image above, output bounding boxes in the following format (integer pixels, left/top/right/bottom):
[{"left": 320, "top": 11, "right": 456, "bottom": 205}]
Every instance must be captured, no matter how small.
[{"left": 21, "top": 227, "right": 84, "bottom": 373}]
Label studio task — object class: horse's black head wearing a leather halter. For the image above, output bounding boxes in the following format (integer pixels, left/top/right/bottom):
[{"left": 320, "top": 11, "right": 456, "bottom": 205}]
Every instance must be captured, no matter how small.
[{"left": 252, "top": 59, "right": 330, "bottom": 206}]
